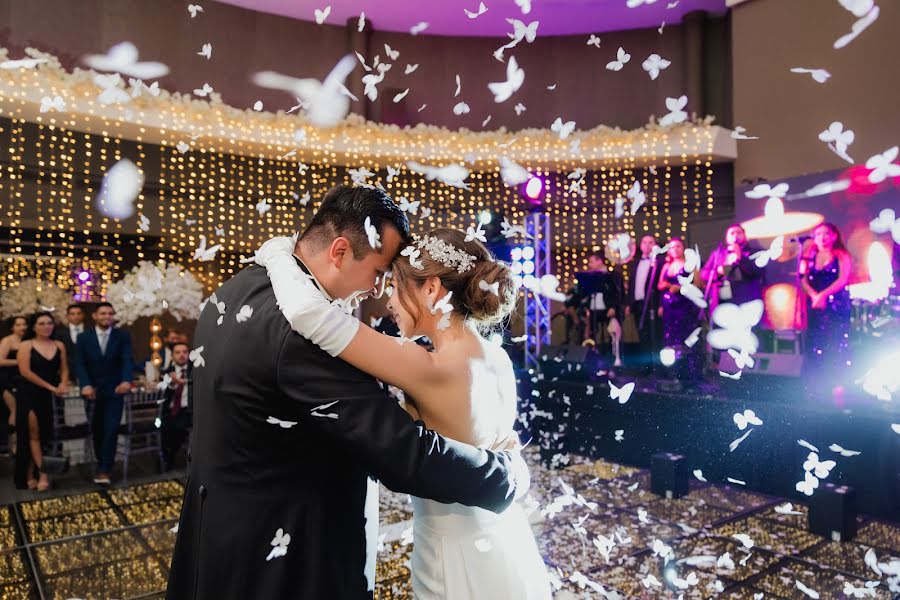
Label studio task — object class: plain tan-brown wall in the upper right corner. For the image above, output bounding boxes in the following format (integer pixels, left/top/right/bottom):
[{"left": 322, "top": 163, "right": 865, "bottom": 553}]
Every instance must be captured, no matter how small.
[{"left": 731, "top": 0, "right": 900, "bottom": 181}]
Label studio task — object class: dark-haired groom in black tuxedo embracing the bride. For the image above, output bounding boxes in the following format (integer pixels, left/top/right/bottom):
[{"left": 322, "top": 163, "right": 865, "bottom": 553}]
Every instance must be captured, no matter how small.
[{"left": 166, "top": 186, "right": 528, "bottom": 600}]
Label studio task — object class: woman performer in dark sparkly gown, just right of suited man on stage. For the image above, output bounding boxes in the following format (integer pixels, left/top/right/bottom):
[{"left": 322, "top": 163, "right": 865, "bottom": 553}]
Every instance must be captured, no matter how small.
[{"left": 657, "top": 237, "right": 700, "bottom": 384}]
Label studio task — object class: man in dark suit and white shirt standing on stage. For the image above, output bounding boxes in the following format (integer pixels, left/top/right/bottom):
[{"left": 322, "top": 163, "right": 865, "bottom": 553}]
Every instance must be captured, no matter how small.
[{"left": 625, "top": 235, "right": 664, "bottom": 371}]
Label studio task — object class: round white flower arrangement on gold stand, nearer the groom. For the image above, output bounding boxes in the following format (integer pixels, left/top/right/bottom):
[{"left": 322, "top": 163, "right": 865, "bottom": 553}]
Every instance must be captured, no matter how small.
[{"left": 106, "top": 260, "right": 203, "bottom": 325}]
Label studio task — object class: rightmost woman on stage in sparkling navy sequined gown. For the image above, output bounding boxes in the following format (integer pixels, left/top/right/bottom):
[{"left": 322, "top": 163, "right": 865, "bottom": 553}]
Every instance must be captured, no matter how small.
[{"left": 800, "top": 223, "right": 852, "bottom": 396}]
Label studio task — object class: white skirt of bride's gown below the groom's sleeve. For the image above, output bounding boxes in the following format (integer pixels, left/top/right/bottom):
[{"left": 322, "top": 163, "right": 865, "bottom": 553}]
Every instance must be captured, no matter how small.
[{"left": 410, "top": 498, "right": 551, "bottom": 600}]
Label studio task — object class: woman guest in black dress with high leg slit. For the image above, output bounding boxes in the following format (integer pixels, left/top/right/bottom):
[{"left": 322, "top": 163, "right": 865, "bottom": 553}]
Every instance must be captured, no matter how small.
[{"left": 15, "top": 312, "right": 69, "bottom": 492}]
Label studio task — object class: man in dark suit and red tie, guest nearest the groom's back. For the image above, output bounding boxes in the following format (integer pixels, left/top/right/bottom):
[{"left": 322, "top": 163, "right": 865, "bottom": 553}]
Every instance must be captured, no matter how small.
[{"left": 160, "top": 342, "right": 193, "bottom": 471}]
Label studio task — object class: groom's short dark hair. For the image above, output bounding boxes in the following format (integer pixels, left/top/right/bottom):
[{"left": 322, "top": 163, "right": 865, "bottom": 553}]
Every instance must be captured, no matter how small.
[{"left": 299, "top": 185, "right": 410, "bottom": 260}]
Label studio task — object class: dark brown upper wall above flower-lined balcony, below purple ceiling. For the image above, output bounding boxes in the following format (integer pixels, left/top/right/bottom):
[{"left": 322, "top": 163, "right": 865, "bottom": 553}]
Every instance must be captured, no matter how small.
[{"left": 0, "top": 0, "right": 729, "bottom": 130}]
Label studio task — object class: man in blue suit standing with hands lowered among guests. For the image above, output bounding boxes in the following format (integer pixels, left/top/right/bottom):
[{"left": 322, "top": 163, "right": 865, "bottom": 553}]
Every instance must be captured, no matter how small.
[{"left": 75, "top": 302, "right": 134, "bottom": 485}]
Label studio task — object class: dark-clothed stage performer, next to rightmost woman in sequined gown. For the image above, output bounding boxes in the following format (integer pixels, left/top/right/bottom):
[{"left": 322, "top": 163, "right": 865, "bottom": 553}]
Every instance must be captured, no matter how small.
[{"left": 700, "top": 224, "right": 764, "bottom": 315}]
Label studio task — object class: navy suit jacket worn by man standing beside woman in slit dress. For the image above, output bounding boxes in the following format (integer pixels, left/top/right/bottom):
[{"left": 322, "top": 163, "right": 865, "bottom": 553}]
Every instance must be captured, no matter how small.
[{"left": 75, "top": 327, "right": 134, "bottom": 394}]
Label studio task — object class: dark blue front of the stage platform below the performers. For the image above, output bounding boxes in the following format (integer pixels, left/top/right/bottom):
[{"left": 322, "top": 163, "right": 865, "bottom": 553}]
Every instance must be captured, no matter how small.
[{"left": 519, "top": 373, "right": 900, "bottom": 519}]
